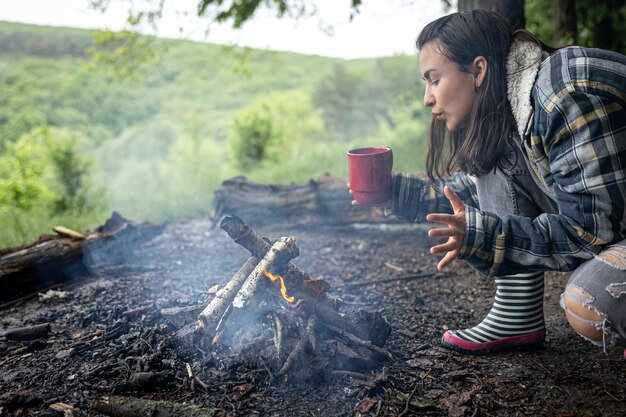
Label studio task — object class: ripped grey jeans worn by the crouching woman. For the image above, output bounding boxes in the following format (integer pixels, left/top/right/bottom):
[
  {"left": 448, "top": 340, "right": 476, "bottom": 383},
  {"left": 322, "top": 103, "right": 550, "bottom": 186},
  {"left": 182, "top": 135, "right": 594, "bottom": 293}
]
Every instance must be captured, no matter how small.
[{"left": 476, "top": 146, "right": 626, "bottom": 347}]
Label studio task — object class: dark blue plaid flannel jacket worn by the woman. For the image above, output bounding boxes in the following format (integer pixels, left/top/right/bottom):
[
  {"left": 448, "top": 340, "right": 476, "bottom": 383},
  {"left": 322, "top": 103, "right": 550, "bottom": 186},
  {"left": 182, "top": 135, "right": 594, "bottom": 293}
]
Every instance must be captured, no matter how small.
[{"left": 392, "top": 47, "right": 626, "bottom": 276}]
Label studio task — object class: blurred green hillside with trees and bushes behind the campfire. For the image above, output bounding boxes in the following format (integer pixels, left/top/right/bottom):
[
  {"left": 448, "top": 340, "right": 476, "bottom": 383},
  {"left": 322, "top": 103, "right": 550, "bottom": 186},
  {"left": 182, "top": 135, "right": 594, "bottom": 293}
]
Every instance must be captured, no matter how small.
[{"left": 0, "top": 22, "right": 425, "bottom": 246}]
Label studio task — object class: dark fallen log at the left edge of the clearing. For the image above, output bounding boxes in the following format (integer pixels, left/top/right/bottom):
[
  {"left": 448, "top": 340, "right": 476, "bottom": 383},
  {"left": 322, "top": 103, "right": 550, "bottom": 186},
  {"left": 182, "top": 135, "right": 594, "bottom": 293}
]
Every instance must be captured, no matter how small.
[{"left": 0, "top": 212, "right": 165, "bottom": 301}]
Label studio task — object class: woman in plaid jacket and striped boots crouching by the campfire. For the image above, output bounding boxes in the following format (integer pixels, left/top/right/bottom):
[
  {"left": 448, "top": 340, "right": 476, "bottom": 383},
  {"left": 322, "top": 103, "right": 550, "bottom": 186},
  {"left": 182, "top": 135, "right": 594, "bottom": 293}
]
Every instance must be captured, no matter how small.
[{"left": 352, "top": 10, "right": 626, "bottom": 358}]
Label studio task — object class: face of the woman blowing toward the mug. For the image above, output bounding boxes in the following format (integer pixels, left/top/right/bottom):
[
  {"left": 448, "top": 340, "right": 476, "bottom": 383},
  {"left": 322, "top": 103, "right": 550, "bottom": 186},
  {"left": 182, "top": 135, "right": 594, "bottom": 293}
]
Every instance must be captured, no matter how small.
[{"left": 419, "top": 41, "right": 477, "bottom": 132}]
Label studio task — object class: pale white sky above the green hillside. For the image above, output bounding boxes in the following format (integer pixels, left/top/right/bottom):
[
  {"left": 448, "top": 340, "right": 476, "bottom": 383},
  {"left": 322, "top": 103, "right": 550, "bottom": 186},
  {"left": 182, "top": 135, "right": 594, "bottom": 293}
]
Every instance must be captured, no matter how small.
[{"left": 0, "top": 0, "right": 446, "bottom": 59}]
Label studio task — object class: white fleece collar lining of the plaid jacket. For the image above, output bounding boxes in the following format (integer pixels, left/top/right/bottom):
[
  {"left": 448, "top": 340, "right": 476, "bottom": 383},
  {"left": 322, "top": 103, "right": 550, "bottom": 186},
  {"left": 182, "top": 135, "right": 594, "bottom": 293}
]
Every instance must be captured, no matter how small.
[{"left": 506, "top": 39, "right": 548, "bottom": 138}]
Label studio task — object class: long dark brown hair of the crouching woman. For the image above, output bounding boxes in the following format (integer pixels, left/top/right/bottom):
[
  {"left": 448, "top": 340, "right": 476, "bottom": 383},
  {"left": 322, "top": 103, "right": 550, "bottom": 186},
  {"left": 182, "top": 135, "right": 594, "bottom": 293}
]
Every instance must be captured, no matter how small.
[{"left": 416, "top": 10, "right": 554, "bottom": 183}]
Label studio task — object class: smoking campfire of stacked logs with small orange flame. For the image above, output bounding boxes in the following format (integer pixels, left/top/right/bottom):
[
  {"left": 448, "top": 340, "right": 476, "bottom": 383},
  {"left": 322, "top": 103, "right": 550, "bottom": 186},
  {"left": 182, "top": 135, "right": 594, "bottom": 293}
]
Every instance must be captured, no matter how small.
[{"left": 179, "top": 216, "right": 393, "bottom": 381}]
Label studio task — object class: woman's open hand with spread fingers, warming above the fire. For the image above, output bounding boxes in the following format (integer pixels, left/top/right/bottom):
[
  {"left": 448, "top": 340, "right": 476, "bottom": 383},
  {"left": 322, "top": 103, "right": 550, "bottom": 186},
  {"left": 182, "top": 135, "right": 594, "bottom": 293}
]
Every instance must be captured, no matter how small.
[{"left": 426, "top": 185, "right": 465, "bottom": 271}]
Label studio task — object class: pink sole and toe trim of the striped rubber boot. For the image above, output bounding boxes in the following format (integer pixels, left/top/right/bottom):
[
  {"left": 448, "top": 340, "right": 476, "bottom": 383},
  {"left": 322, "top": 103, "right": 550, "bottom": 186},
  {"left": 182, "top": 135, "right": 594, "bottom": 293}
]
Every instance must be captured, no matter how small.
[{"left": 441, "top": 330, "right": 544, "bottom": 355}]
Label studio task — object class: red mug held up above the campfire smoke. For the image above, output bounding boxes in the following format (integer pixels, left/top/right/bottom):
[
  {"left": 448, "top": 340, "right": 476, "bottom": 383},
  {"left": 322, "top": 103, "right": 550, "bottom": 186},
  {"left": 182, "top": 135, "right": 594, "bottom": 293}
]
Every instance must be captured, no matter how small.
[{"left": 348, "top": 147, "right": 393, "bottom": 204}]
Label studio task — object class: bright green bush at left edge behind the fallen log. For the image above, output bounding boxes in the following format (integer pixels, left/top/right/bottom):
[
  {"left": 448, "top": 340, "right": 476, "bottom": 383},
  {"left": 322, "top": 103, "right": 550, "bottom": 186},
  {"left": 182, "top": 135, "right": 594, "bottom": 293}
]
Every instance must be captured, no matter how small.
[{"left": 0, "top": 128, "right": 99, "bottom": 245}]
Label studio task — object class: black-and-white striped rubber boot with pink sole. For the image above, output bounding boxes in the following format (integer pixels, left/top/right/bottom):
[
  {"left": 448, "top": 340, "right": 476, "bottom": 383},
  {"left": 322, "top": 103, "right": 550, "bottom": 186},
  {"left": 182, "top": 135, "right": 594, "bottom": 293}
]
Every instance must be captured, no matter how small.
[{"left": 442, "top": 272, "right": 546, "bottom": 355}]
